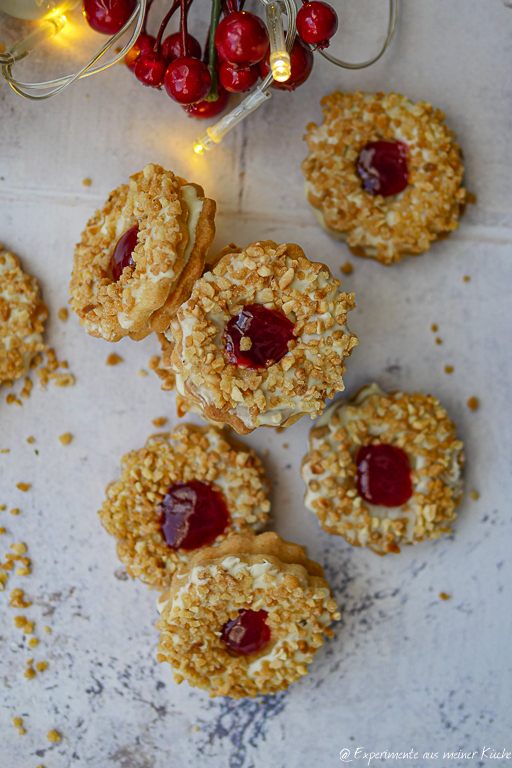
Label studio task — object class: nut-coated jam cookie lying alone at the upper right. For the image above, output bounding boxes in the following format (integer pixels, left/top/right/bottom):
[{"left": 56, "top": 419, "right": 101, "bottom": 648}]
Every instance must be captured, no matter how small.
[{"left": 302, "top": 91, "right": 466, "bottom": 265}]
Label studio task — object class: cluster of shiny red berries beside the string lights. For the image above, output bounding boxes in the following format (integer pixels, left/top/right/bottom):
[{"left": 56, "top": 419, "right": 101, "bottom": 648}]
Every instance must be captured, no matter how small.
[{"left": 82, "top": 0, "right": 338, "bottom": 118}]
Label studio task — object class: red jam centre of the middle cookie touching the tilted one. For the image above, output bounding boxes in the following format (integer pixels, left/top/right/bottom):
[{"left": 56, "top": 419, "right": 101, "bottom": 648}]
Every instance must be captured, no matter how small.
[{"left": 224, "top": 304, "right": 295, "bottom": 368}]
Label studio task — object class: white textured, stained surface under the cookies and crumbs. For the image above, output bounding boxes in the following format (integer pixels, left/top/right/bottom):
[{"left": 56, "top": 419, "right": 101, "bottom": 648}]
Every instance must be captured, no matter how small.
[{"left": 0, "top": 0, "right": 512, "bottom": 768}]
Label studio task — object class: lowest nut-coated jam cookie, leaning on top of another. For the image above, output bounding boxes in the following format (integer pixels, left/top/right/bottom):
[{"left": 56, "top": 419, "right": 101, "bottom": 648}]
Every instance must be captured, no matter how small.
[{"left": 157, "top": 533, "right": 340, "bottom": 699}]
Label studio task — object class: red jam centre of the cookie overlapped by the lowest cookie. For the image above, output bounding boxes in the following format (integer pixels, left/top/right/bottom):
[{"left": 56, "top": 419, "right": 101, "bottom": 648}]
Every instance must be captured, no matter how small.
[{"left": 160, "top": 480, "right": 229, "bottom": 549}]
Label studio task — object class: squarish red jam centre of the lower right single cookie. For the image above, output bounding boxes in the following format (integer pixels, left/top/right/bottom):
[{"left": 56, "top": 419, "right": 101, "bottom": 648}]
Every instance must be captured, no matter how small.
[{"left": 356, "top": 443, "right": 412, "bottom": 507}]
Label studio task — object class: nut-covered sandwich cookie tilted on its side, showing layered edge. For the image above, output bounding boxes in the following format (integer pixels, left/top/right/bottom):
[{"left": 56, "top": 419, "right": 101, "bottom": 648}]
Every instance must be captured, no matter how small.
[{"left": 69, "top": 164, "right": 216, "bottom": 341}]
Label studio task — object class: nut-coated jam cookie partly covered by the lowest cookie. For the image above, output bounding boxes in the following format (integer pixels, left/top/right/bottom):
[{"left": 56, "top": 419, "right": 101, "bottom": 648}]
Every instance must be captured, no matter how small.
[{"left": 98, "top": 424, "right": 270, "bottom": 589}]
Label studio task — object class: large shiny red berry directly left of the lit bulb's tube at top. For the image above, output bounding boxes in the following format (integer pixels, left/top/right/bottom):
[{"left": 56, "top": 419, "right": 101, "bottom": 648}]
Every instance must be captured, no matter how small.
[{"left": 215, "top": 11, "right": 268, "bottom": 67}]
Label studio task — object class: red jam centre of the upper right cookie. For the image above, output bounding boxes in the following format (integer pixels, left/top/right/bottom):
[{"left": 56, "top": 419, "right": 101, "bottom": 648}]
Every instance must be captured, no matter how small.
[{"left": 357, "top": 141, "right": 409, "bottom": 197}]
